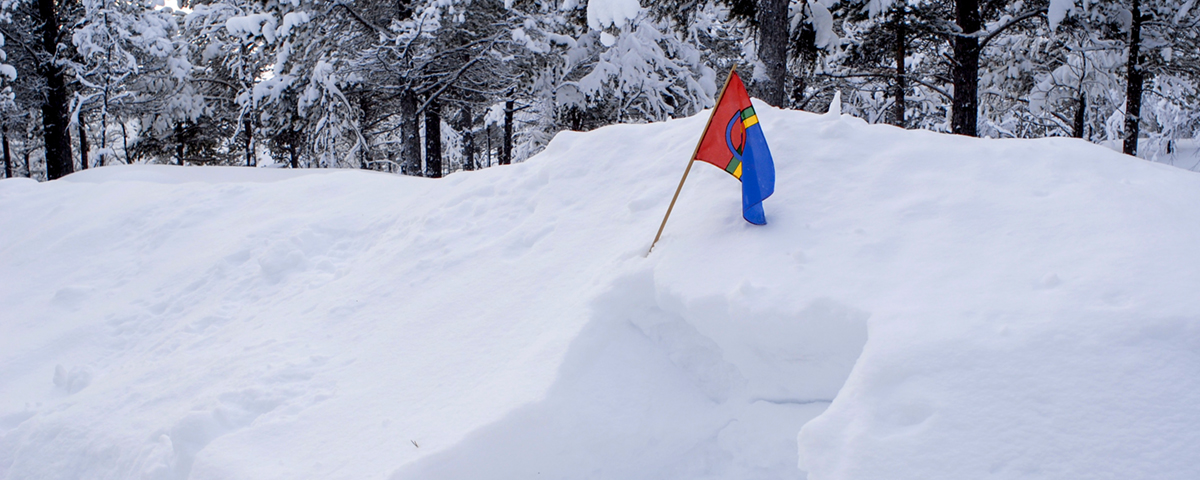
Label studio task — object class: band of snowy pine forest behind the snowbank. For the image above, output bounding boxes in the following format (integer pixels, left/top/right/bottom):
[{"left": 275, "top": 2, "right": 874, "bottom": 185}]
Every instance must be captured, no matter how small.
[{"left": 0, "top": 0, "right": 1200, "bottom": 180}]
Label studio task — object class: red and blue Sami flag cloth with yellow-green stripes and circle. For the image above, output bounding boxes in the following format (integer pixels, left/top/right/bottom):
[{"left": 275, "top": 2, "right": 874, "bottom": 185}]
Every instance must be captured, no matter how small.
[{"left": 695, "top": 71, "right": 775, "bottom": 224}]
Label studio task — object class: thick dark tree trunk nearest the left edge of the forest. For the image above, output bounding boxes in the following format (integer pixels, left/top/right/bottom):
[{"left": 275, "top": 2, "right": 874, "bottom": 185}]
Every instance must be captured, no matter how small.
[{"left": 37, "top": 0, "right": 74, "bottom": 180}]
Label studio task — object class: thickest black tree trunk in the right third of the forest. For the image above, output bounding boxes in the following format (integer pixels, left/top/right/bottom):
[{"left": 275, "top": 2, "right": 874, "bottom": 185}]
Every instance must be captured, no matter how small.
[{"left": 950, "top": 0, "right": 980, "bottom": 137}]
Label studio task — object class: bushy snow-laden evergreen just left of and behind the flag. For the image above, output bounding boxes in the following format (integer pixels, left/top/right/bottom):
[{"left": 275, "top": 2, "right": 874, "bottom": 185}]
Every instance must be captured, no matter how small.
[{"left": 516, "top": 2, "right": 718, "bottom": 148}]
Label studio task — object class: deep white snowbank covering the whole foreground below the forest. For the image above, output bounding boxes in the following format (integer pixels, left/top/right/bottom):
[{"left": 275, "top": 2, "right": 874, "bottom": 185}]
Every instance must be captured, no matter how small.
[{"left": 0, "top": 106, "right": 1200, "bottom": 480}]
